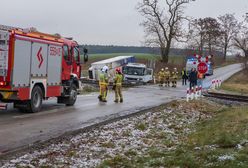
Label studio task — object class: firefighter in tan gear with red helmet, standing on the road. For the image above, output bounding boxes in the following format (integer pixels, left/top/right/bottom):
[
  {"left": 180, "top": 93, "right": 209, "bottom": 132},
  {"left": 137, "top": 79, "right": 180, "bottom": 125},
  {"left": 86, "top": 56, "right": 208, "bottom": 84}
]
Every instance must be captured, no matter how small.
[{"left": 113, "top": 68, "right": 123, "bottom": 103}]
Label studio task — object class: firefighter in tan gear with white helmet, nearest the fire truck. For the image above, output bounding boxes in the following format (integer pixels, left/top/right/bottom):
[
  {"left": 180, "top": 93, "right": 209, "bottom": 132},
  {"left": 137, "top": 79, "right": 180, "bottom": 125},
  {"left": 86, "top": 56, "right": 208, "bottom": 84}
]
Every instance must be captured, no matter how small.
[{"left": 98, "top": 66, "right": 109, "bottom": 102}]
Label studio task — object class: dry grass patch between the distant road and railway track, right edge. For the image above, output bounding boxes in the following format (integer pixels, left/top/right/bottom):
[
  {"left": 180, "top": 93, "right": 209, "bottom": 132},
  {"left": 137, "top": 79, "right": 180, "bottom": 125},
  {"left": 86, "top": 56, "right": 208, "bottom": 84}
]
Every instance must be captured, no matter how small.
[{"left": 221, "top": 70, "right": 248, "bottom": 94}]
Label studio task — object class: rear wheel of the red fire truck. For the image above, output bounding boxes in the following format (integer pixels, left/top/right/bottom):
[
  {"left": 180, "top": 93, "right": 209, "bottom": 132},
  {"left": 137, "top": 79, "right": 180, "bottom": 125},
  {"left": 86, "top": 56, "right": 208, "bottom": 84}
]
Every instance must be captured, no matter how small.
[{"left": 27, "top": 86, "right": 43, "bottom": 113}]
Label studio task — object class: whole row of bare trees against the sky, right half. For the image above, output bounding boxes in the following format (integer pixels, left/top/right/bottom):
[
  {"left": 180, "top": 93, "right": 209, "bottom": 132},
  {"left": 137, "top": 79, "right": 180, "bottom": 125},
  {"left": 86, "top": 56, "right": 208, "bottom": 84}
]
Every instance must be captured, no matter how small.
[{"left": 137, "top": 0, "right": 248, "bottom": 63}]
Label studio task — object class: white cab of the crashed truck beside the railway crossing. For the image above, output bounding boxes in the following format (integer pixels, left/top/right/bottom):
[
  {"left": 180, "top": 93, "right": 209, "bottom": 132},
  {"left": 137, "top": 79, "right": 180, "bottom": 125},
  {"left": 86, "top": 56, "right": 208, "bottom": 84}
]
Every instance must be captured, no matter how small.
[{"left": 122, "top": 63, "right": 153, "bottom": 83}]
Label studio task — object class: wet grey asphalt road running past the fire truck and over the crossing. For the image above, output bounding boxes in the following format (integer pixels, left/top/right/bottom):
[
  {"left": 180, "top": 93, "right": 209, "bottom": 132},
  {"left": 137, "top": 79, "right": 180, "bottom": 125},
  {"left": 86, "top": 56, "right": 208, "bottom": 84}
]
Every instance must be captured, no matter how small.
[{"left": 0, "top": 64, "right": 241, "bottom": 154}]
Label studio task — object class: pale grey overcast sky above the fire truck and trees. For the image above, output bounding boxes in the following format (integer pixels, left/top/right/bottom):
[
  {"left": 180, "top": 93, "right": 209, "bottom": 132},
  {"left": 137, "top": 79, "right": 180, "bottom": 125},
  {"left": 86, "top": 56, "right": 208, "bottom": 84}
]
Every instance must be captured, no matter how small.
[{"left": 0, "top": 0, "right": 248, "bottom": 46}]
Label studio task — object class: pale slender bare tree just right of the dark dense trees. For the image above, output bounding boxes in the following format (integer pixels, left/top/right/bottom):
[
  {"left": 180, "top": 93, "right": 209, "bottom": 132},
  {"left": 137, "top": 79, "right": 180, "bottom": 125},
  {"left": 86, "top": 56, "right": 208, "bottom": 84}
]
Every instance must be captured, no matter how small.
[{"left": 218, "top": 14, "right": 239, "bottom": 60}]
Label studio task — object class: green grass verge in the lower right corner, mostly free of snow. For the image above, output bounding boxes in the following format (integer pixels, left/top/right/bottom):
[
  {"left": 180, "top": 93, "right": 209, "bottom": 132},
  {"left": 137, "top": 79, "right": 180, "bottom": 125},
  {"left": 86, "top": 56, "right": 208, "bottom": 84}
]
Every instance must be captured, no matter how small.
[{"left": 99, "top": 102, "right": 248, "bottom": 168}]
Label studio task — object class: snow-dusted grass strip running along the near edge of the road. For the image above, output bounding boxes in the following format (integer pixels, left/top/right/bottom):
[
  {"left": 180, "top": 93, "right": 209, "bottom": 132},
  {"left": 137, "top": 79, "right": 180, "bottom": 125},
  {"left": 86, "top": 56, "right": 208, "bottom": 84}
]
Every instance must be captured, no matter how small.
[{"left": 2, "top": 100, "right": 215, "bottom": 168}]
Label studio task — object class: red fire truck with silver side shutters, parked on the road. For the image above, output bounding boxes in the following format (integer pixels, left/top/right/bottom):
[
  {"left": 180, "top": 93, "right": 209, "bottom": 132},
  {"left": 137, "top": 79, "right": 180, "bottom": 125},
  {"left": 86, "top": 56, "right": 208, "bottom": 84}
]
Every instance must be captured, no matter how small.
[{"left": 0, "top": 26, "right": 87, "bottom": 112}]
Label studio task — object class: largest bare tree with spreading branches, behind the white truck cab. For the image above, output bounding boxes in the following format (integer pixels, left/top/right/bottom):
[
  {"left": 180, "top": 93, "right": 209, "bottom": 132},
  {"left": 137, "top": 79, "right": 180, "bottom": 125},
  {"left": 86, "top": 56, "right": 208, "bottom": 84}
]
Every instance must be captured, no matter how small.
[{"left": 138, "top": 0, "right": 194, "bottom": 63}]
